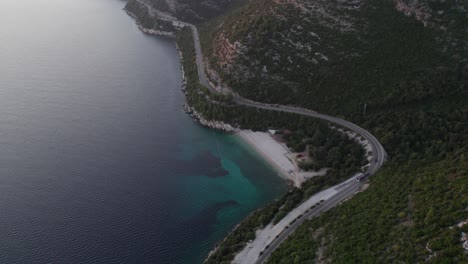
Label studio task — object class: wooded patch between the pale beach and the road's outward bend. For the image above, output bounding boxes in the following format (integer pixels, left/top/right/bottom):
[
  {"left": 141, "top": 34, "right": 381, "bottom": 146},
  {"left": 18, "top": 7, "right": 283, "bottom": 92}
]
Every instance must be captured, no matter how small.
[{"left": 177, "top": 29, "right": 364, "bottom": 175}]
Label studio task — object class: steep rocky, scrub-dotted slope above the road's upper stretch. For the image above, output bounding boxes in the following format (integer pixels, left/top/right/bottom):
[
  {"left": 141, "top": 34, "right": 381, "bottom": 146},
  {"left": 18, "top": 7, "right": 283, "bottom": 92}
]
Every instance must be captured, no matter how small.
[{"left": 205, "top": 0, "right": 468, "bottom": 113}]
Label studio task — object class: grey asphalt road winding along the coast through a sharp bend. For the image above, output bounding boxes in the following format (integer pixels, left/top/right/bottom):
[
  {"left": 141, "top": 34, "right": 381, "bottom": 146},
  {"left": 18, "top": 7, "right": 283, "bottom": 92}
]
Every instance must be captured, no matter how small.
[{"left": 131, "top": 0, "right": 387, "bottom": 264}]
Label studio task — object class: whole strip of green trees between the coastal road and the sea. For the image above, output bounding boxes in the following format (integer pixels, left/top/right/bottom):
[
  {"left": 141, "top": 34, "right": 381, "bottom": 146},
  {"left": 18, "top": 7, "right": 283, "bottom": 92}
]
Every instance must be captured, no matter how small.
[{"left": 177, "top": 29, "right": 370, "bottom": 263}]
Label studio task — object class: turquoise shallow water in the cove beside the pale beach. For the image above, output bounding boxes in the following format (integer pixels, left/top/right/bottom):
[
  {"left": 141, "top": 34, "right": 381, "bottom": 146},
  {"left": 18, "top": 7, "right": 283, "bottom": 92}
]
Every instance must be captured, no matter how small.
[{"left": 174, "top": 132, "right": 287, "bottom": 259}]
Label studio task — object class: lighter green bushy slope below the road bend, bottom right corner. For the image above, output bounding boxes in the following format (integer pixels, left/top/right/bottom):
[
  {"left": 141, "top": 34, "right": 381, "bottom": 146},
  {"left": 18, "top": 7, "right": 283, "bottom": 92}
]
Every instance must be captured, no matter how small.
[{"left": 268, "top": 157, "right": 468, "bottom": 263}]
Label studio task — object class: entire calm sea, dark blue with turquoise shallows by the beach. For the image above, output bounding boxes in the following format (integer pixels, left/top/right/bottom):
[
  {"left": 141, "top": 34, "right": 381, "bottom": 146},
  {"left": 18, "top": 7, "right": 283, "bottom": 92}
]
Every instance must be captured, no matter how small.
[{"left": 0, "top": 0, "right": 286, "bottom": 263}]
